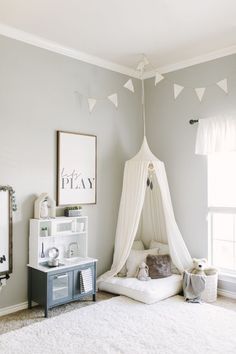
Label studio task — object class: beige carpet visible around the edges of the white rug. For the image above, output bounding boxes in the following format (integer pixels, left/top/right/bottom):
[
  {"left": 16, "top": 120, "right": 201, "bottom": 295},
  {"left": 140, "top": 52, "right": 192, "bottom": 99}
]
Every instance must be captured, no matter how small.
[{"left": 0, "top": 292, "right": 236, "bottom": 334}]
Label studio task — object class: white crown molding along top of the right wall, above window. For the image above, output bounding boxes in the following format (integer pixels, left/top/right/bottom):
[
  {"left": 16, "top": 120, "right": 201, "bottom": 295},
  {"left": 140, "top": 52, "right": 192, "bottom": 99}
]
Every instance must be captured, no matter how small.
[{"left": 144, "top": 45, "right": 236, "bottom": 79}]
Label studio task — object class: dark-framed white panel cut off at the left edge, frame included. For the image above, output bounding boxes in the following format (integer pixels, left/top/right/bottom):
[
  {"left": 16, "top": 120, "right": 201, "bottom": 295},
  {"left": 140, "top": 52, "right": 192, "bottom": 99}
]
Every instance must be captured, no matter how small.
[{"left": 0, "top": 186, "right": 14, "bottom": 276}]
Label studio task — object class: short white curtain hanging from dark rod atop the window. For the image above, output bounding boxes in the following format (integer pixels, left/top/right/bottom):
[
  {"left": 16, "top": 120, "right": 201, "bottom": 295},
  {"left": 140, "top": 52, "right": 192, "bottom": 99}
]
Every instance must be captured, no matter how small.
[{"left": 195, "top": 117, "right": 236, "bottom": 155}]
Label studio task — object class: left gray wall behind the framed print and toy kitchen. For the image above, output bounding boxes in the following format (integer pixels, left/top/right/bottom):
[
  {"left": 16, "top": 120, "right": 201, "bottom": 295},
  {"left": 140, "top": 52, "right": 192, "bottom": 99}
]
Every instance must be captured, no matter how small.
[{"left": 0, "top": 37, "right": 142, "bottom": 307}]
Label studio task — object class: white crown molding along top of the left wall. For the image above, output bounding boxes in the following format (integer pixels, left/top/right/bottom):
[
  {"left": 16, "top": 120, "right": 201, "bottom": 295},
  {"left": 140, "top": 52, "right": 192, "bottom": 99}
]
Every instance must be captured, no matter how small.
[{"left": 0, "top": 23, "right": 140, "bottom": 78}]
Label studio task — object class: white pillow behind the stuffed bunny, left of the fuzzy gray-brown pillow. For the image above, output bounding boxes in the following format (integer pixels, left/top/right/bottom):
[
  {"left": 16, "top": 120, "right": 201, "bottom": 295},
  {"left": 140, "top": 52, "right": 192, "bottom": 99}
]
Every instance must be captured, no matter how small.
[{"left": 126, "top": 248, "right": 159, "bottom": 278}]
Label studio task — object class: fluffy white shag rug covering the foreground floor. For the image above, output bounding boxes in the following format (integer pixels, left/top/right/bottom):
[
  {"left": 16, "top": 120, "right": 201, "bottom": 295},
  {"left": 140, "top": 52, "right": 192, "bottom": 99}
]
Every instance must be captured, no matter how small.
[{"left": 0, "top": 296, "right": 236, "bottom": 354}]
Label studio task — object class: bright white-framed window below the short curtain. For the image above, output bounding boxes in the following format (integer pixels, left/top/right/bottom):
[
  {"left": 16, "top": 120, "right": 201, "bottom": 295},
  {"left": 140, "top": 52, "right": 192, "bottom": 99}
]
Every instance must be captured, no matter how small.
[{"left": 208, "top": 152, "right": 236, "bottom": 274}]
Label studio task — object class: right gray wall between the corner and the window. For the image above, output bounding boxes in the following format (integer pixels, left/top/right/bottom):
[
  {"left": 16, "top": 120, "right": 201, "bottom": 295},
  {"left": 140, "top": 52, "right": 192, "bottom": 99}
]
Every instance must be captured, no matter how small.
[{"left": 145, "top": 55, "right": 236, "bottom": 291}]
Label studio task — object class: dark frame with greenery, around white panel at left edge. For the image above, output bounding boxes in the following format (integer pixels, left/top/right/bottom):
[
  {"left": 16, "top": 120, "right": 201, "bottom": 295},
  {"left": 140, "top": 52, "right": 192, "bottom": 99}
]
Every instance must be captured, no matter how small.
[{"left": 0, "top": 186, "right": 13, "bottom": 276}]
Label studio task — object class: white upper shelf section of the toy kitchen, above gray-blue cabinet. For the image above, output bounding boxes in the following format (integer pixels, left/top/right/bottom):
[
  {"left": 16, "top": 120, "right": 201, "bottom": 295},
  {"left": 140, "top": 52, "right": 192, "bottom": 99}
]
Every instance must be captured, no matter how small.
[{"left": 29, "top": 216, "right": 88, "bottom": 267}]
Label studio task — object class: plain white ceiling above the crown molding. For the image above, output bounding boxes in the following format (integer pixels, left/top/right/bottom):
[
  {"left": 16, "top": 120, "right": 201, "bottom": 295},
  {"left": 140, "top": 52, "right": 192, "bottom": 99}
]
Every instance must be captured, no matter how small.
[{"left": 0, "top": 0, "right": 236, "bottom": 76}]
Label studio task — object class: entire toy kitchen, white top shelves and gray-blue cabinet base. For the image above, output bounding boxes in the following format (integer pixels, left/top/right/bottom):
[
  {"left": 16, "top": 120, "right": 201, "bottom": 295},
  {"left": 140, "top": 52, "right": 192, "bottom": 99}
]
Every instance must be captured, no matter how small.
[{"left": 28, "top": 216, "right": 97, "bottom": 317}]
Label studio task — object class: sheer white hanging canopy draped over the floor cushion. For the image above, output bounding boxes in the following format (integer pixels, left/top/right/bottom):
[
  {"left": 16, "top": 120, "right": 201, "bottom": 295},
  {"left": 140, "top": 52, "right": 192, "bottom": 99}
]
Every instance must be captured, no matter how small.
[{"left": 98, "top": 137, "right": 192, "bottom": 282}]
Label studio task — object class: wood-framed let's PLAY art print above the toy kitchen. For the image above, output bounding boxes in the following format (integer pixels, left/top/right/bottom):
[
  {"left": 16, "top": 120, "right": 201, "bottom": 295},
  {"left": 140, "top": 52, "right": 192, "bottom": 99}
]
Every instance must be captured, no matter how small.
[{"left": 57, "top": 131, "right": 97, "bottom": 205}]
